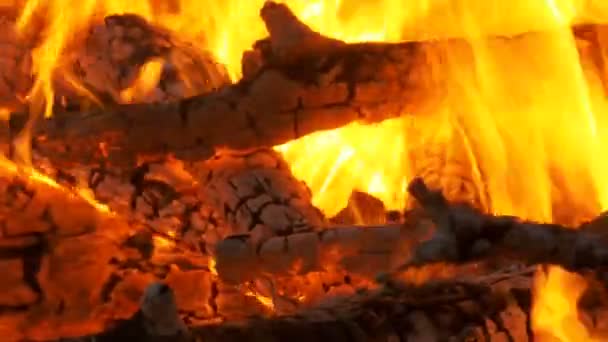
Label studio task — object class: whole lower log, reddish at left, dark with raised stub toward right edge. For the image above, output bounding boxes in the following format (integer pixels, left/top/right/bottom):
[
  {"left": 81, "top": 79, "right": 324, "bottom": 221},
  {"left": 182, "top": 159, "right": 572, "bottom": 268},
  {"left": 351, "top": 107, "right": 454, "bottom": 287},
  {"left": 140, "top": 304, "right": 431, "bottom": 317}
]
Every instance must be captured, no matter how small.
[{"left": 215, "top": 175, "right": 608, "bottom": 283}]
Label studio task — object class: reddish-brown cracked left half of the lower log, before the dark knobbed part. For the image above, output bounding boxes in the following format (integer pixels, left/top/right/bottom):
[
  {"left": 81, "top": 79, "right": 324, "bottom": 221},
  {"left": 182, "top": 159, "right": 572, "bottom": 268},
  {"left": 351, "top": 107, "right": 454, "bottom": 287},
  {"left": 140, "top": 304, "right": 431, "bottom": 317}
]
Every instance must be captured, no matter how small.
[{"left": 214, "top": 216, "right": 433, "bottom": 283}]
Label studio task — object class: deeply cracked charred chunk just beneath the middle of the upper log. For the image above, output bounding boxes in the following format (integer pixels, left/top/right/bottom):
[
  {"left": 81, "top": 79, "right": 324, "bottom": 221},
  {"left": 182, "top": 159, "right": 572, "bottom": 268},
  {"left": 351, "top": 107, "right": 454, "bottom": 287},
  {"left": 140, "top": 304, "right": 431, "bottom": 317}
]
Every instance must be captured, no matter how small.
[{"left": 192, "top": 149, "right": 325, "bottom": 246}]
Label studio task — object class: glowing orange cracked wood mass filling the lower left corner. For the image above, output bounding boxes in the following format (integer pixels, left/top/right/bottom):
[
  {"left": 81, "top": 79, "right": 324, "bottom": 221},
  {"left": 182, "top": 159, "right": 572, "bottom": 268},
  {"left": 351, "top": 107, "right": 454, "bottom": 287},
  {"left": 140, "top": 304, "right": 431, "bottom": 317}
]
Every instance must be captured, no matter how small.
[{"left": 0, "top": 164, "right": 290, "bottom": 341}]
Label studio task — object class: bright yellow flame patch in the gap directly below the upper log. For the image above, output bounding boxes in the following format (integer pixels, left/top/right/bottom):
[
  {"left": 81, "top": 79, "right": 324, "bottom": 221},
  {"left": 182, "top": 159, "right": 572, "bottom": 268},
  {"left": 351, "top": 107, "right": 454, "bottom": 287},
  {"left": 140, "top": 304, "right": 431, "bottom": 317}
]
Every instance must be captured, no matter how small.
[{"left": 276, "top": 119, "right": 407, "bottom": 216}]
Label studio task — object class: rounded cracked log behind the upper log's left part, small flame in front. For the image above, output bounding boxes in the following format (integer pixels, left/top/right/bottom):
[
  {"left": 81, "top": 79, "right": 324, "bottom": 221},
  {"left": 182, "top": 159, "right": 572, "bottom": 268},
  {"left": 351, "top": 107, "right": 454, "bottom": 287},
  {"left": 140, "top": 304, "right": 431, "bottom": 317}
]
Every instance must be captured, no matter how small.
[{"left": 63, "top": 15, "right": 230, "bottom": 104}]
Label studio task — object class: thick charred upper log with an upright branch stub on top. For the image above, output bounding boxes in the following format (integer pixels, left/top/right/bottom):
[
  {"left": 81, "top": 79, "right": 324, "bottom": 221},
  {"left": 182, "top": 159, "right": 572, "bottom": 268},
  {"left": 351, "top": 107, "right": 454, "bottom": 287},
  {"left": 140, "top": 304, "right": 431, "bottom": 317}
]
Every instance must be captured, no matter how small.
[{"left": 1, "top": 3, "right": 603, "bottom": 168}]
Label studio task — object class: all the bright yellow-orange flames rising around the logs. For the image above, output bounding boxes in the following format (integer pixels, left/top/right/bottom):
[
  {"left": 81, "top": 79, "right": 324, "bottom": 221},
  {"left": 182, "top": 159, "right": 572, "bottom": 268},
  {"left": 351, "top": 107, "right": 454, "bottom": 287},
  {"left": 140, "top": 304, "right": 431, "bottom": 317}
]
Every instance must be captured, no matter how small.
[{"left": 10, "top": 0, "right": 608, "bottom": 341}]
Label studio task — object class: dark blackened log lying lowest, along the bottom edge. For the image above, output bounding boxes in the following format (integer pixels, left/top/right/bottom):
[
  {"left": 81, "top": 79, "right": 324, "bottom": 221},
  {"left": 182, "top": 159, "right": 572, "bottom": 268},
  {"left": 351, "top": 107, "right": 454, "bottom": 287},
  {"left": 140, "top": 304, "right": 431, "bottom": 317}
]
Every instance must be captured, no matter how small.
[{"left": 78, "top": 270, "right": 606, "bottom": 342}]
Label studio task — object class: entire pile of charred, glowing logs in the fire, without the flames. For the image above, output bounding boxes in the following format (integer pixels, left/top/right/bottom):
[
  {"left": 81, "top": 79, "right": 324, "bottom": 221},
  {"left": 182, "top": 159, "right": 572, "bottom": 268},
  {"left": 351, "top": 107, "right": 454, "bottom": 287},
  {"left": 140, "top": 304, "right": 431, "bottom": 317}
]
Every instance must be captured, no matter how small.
[{"left": 0, "top": 2, "right": 608, "bottom": 341}]
